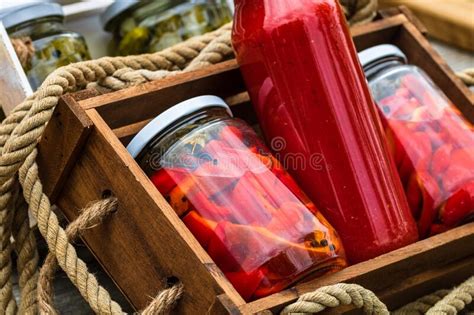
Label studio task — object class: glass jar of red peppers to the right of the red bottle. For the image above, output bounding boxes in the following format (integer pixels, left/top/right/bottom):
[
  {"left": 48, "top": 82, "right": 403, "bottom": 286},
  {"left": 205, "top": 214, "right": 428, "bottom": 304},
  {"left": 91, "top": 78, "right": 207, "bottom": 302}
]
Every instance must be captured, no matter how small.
[{"left": 359, "top": 45, "right": 474, "bottom": 237}]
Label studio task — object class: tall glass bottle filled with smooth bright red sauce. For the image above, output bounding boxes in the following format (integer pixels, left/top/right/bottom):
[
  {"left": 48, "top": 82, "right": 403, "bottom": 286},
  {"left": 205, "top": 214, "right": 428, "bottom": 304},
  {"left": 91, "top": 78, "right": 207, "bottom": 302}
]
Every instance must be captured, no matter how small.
[{"left": 233, "top": 0, "right": 418, "bottom": 263}]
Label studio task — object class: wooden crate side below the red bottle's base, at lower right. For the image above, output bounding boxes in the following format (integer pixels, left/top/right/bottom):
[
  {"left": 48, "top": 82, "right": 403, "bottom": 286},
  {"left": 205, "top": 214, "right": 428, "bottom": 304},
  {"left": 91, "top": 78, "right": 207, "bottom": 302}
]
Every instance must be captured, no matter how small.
[{"left": 240, "top": 223, "right": 474, "bottom": 314}]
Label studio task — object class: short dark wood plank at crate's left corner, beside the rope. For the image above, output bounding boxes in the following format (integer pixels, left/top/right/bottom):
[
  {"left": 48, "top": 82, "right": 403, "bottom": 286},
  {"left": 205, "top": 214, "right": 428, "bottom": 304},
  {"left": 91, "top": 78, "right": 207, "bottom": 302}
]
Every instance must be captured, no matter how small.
[{"left": 36, "top": 94, "right": 93, "bottom": 203}]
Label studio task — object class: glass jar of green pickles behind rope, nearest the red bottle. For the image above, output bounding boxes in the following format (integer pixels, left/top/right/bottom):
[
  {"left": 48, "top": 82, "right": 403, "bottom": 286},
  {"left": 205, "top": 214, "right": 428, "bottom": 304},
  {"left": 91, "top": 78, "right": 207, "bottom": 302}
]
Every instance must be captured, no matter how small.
[{"left": 102, "top": 0, "right": 232, "bottom": 55}]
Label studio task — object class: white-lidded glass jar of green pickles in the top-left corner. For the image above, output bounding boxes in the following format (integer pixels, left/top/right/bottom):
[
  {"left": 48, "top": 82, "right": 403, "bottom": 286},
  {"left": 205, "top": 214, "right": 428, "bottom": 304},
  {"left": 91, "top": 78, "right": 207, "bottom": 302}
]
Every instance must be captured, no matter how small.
[{"left": 0, "top": 3, "right": 90, "bottom": 90}]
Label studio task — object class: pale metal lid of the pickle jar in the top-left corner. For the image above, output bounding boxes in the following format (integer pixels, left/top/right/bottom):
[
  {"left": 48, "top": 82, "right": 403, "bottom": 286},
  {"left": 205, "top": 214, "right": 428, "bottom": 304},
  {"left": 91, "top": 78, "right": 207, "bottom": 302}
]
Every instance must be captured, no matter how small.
[{"left": 0, "top": 2, "right": 64, "bottom": 29}]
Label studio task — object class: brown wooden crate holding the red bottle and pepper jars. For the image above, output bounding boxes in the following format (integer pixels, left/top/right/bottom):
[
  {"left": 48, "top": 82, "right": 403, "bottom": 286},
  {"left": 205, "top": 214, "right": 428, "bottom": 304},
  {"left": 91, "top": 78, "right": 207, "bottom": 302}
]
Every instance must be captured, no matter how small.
[{"left": 38, "top": 14, "right": 474, "bottom": 314}]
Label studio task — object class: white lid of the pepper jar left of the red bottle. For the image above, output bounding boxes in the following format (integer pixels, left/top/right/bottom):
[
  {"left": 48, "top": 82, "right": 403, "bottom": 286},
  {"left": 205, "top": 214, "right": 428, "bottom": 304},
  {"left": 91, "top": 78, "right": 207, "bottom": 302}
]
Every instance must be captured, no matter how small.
[{"left": 127, "top": 95, "right": 233, "bottom": 158}]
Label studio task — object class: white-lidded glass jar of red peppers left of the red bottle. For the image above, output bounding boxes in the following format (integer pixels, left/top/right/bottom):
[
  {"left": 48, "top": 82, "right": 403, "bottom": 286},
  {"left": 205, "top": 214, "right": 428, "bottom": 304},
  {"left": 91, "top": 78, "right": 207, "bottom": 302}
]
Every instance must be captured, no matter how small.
[{"left": 127, "top": 96, "right": 346, "bottom": 301}]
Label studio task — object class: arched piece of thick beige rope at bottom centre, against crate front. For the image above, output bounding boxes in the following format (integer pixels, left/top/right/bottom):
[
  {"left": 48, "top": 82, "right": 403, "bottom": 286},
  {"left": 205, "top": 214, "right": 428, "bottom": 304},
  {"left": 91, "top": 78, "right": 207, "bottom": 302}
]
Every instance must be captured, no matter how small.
[{"left": 281, "top": 283, "right": 389, "bottom": 315}]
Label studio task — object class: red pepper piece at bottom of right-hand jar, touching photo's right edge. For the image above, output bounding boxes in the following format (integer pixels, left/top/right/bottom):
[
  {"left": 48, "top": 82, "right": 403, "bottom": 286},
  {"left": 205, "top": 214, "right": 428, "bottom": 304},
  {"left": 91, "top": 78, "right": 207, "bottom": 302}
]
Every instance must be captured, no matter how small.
[{"left": 440, "top": 181, "right": 474, "bottom": 227}]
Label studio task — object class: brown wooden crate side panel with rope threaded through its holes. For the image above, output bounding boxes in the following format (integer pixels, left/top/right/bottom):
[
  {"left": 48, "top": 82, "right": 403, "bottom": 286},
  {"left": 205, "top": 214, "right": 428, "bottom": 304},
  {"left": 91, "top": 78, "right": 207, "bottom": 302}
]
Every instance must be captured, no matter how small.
[{"left": 58, "top": 109, "right": 243, "bottom": 314}]
